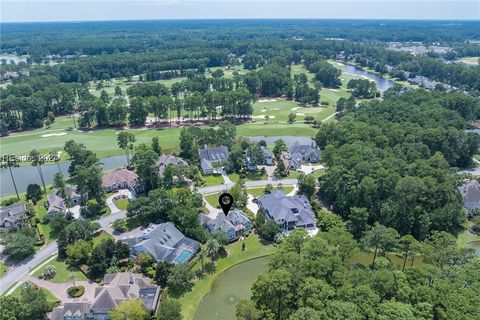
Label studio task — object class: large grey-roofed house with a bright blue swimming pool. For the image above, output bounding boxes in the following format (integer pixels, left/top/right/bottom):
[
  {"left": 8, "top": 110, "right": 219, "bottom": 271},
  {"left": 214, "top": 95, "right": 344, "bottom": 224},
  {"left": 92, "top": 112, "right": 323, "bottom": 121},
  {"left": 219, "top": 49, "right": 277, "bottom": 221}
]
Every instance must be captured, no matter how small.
[{"left": 119, "top": 222, "right": 200, "bottom": 264}]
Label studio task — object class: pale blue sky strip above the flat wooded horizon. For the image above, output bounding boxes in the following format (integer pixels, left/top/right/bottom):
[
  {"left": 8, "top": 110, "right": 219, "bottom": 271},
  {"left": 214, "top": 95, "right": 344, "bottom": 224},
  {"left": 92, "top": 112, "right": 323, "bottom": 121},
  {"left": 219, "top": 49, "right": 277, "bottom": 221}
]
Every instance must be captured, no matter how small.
[{"left": 0, "top": 0, "right": 480, "bottom": 22}]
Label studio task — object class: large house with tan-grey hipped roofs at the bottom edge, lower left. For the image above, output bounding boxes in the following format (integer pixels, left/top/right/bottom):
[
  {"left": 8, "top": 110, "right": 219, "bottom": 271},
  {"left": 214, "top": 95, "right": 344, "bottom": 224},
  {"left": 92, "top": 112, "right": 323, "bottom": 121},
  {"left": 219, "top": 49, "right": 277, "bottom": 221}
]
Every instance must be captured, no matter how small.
[{"left": 51, "top": 272, "right": 161, "bottom": 320}]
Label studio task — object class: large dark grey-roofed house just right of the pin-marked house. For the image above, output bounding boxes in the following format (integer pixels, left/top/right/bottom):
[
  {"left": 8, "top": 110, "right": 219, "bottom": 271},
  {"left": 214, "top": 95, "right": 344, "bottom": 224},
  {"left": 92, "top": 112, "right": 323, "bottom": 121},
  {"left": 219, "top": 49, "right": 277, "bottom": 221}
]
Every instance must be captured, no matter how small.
[{"left": 258, "top": 190, "right": 316, "bottom": 231}]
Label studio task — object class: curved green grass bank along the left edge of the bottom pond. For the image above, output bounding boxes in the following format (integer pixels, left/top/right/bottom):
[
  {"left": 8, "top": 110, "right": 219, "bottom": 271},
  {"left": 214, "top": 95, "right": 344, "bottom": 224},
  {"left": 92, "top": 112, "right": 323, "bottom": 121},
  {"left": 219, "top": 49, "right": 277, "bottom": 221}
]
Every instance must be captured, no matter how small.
[{"left": 179, "top": 234, "right": 275, "bottom": 320}]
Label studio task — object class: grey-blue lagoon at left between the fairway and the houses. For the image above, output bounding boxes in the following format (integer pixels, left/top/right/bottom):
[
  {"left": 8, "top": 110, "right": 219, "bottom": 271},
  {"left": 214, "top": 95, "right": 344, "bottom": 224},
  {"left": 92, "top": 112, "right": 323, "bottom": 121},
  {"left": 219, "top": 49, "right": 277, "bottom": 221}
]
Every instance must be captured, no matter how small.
[{"left": 0, "top": 156, "right": 127, "bottom": 197}]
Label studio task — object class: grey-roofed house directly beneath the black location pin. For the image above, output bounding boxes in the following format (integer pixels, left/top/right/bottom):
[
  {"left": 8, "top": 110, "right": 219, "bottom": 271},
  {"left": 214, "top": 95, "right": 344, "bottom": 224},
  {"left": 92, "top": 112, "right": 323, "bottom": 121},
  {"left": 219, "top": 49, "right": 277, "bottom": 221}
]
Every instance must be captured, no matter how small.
[{"left": 200, "top": 209, "right": 252, "bottom": 242}]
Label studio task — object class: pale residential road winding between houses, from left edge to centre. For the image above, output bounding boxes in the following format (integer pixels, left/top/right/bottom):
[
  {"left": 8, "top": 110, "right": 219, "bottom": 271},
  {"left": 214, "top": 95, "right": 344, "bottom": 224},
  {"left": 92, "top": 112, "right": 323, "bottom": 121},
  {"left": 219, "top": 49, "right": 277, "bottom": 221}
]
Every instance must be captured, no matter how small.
[{"left": 0, "top": 179, "right": 298, "bottom": 294}]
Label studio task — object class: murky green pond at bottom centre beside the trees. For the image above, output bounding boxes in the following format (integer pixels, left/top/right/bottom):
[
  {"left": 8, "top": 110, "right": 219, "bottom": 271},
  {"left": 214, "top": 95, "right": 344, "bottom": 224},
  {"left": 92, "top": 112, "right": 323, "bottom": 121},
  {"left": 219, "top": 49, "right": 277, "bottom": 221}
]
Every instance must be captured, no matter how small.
[{"left": 194, "top": 257, "right": 269, "bottom": 320}]
